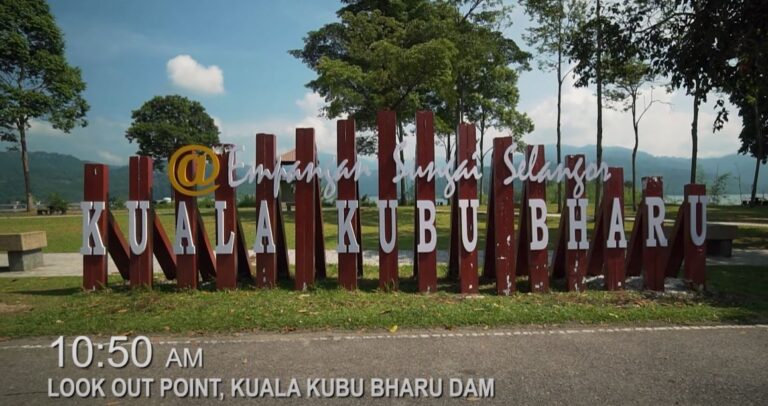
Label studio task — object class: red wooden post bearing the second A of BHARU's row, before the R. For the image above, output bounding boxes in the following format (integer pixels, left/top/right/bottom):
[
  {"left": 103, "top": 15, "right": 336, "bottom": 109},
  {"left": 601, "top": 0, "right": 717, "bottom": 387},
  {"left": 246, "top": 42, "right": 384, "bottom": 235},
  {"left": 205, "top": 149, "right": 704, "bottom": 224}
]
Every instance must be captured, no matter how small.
[{"left": 604, "top": 168, "right": 627, "bottom": 290}]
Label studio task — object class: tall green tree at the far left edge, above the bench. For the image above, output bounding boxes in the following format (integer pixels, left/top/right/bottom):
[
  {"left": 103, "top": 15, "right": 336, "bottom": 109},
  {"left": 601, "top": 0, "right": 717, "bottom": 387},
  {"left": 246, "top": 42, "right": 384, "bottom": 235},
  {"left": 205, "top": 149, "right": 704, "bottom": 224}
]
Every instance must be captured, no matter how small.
[{"left": 0, "top": 0, "right": 88, "bottom": 211}]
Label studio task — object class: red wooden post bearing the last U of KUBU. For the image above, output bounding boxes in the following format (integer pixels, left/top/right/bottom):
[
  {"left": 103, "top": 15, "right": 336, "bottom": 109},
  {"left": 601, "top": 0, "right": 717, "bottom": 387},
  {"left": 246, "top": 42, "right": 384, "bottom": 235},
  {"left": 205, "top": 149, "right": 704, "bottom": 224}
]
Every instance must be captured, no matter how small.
[{"left": 456, "top": 123, "right": 479, "bottom": 293}]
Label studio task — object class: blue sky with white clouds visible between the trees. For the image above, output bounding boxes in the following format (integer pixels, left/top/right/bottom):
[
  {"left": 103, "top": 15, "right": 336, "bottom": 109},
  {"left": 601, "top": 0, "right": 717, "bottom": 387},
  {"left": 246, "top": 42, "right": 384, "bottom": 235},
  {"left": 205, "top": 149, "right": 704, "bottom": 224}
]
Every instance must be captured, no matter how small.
[{"left": 21, "top": 0, "right": 739, "bottom": 164}]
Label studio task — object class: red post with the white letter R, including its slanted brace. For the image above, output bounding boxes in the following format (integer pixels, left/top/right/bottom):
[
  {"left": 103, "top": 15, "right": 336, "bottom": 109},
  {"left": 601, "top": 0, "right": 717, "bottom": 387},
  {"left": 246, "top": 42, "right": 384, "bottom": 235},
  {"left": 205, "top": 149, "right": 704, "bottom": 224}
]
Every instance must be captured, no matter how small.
[{"left": 624, "top": 176, "right": 668, "bottom": 291}]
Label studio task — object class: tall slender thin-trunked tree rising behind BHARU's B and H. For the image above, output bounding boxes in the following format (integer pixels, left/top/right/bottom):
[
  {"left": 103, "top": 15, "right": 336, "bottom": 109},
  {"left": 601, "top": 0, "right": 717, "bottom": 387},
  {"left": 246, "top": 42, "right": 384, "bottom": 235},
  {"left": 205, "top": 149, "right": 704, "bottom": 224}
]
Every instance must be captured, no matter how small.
[{"left": 522, "top": 0, "right": 586, "bottom": 211}]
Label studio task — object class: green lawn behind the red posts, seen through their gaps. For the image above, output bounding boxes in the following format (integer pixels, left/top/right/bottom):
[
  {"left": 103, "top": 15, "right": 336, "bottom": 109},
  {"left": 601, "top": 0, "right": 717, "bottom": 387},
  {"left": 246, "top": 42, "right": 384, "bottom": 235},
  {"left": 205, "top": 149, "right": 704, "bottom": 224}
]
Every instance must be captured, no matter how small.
[{"left": 0, "top": 205, "right": 768, "bottom": 252}]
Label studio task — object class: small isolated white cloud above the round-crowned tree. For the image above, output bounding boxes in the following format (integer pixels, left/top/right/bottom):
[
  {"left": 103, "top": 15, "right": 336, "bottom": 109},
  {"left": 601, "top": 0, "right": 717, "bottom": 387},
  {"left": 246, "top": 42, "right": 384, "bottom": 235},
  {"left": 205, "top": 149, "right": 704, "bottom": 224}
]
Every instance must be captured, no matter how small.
[{"left": 166, "top": 55, "right": 224, "bottom": 94}]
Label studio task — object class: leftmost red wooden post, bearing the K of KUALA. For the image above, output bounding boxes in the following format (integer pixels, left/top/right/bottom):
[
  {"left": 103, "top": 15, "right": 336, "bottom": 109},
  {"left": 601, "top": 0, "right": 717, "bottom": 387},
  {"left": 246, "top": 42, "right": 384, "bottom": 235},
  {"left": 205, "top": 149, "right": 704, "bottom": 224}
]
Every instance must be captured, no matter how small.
[{"left": 81, "top": 164, "right": 109, "bottom": 290}]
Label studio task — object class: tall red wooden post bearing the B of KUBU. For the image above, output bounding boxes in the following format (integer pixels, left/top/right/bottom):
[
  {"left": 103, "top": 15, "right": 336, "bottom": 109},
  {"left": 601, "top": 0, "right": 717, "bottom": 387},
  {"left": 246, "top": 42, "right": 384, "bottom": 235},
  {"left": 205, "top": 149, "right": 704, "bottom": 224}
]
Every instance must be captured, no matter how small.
[{"left": 414, "top": 111, "right": 437, "bottom": 293}]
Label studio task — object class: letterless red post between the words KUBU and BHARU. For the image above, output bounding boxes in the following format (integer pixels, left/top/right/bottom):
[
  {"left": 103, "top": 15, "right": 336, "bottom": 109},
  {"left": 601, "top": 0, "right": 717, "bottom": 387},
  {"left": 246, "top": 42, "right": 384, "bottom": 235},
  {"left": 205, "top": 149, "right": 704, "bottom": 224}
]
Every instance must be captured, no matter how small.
[{"left": 483, "top": 137, "right": 517, "bottom": 296}]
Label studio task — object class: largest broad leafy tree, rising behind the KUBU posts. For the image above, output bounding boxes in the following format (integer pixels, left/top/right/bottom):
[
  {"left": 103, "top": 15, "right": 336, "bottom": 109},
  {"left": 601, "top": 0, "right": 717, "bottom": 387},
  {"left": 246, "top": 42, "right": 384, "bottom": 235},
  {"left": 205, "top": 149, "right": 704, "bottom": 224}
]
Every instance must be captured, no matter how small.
[{"left": 290, "top": 0, "right": 527, "bottom": 203}]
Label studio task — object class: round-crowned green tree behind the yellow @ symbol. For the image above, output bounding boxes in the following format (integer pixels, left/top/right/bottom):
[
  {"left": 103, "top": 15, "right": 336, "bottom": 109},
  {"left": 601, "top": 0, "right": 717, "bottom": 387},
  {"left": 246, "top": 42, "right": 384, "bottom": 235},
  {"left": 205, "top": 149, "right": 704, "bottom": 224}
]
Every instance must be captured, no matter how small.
[{"left": 125, "top": 95, "right": 219, "bottom": 170}]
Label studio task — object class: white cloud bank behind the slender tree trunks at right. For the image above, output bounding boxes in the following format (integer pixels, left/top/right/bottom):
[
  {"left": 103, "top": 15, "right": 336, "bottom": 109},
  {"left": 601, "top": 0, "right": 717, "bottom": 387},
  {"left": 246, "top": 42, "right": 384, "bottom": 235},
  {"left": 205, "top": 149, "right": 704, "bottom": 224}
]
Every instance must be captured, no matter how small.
[{"left": 524, "top": 76, "right": 740, "bottom": 158}]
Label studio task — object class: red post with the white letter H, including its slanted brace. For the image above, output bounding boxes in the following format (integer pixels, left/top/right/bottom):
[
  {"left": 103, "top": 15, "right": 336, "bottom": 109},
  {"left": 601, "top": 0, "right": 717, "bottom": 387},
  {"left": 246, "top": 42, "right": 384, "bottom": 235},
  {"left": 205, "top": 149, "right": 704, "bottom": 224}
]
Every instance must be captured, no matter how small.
[{"left": 552, "top": 155, "right": 588, "bottom": 292}]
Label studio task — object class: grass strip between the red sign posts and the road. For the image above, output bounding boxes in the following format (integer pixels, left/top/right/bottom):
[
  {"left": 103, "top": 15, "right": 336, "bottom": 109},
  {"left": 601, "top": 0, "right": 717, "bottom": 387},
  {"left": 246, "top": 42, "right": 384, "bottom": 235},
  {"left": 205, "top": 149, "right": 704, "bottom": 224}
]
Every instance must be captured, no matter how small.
[{"left": 0, "top": 266, "right": 768, "bottom": 337}]
